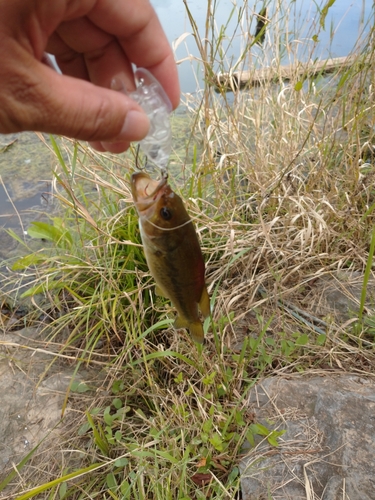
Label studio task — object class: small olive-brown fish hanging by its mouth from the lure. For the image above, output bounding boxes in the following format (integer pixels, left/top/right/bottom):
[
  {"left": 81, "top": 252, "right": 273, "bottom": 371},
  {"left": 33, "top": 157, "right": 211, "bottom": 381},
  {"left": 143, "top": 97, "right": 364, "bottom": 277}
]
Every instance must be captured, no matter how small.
[{"left": 131, "top": 172, "right": 210, "bottom": 344}]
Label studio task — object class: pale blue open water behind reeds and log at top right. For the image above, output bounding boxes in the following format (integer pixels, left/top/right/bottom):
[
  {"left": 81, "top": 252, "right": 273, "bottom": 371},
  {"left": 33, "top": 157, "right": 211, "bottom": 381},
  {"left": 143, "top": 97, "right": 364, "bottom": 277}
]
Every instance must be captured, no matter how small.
[{"left": 151, "top": 0, "right": 374, "bottom": 93}]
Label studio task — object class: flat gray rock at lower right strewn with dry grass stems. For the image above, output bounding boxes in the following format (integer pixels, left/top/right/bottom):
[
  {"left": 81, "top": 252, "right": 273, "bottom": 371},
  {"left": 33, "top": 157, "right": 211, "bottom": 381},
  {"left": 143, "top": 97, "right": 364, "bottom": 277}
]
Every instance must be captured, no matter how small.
[{"left": 240, "top": 374, "right": 375, "bottom": 500}]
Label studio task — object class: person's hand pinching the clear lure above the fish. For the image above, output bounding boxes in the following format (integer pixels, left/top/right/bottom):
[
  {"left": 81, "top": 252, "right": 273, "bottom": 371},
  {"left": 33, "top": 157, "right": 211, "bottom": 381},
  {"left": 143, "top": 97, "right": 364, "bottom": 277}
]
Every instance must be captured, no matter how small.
[{"left": 0, "top": 0, "right": 180, "bottom": 153}]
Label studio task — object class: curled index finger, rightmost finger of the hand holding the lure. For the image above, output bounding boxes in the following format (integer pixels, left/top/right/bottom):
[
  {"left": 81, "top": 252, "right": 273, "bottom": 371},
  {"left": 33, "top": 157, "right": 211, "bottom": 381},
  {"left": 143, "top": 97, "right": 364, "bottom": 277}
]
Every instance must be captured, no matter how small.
[{"left": 88, "top": 0, "right": 180, "bottom": 108}]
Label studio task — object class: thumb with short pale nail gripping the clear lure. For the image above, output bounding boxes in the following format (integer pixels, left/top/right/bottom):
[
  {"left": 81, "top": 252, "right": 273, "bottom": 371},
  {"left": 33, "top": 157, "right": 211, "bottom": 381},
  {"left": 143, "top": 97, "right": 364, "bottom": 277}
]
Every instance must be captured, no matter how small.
[{"left": 2, "top": 60, "right": 150, "bottom": 143}]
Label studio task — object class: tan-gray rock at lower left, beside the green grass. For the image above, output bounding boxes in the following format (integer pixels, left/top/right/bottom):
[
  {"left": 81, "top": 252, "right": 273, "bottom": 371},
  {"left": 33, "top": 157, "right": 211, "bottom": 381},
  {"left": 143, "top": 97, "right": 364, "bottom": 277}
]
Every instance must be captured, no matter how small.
[{"left": 0, "top": 328, "right": 97, "bottom": 484}]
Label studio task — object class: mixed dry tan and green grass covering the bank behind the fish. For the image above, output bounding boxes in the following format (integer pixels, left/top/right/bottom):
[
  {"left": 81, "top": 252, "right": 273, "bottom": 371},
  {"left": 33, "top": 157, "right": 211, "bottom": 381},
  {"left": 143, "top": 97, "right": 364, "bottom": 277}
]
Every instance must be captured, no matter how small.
[{"left": 0, "top": 2, "right": 375, "bottom": 500}]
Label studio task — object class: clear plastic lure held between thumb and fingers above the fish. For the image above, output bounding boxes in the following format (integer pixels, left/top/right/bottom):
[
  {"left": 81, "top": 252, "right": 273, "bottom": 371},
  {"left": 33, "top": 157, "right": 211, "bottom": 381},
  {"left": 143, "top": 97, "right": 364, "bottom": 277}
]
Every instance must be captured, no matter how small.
[{"left": 111, "top": 68, "right": 172, "bottom": 176}]
